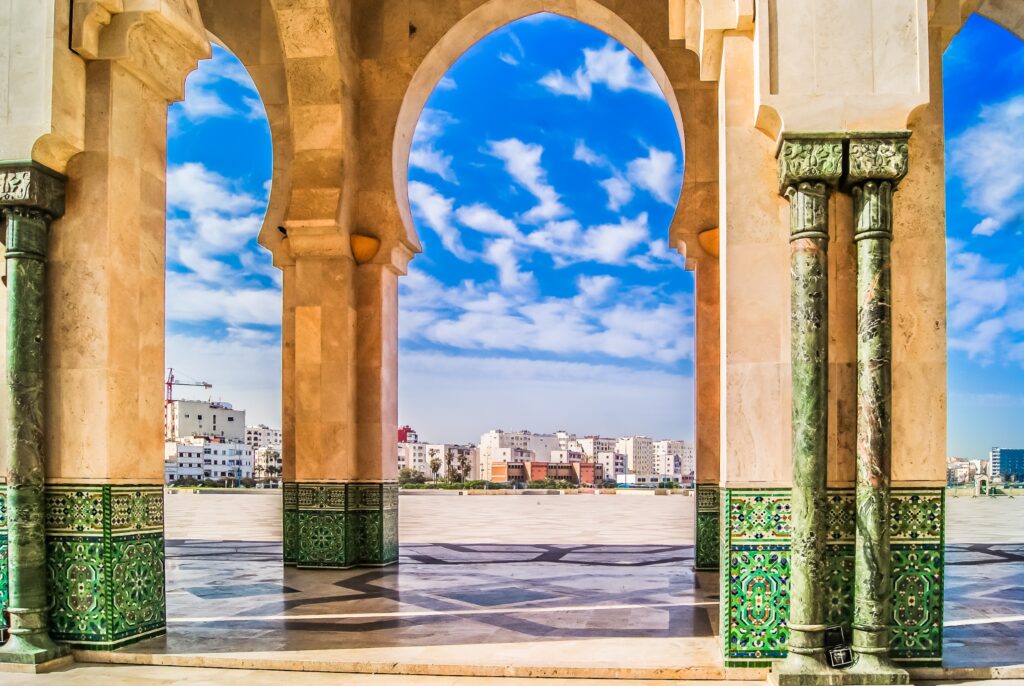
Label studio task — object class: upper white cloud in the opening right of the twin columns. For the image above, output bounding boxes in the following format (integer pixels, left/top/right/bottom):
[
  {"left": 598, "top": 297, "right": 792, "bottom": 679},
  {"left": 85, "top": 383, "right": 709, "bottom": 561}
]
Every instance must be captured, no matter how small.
[{"left": 949, "top": 95, "right": 1024, "bottom": 235}]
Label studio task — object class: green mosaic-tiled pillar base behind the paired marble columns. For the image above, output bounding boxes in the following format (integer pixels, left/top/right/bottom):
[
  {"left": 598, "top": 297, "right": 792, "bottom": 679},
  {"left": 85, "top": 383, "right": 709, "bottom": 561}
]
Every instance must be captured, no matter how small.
[{"left": 721, "top": 488, "right": 945, "bottom": 667}]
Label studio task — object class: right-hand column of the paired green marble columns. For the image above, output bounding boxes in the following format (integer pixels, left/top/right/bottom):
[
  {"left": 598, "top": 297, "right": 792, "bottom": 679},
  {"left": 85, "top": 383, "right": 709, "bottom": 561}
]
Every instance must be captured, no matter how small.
[{"left": 847, "top": 132, "right": 908, "bottom": 683}]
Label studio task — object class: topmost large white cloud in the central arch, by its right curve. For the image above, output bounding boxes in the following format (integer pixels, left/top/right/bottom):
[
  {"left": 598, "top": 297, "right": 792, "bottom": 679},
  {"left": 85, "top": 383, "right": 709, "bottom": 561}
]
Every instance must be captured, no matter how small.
[{"left": 540, "top": 40, "right": 664, "bottom": 100}]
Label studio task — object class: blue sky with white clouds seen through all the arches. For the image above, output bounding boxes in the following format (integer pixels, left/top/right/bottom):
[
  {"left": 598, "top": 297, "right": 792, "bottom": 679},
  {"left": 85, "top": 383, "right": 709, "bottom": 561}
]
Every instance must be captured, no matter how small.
[{"left": 167, "top": 14, "right": 1024, "bottom": 457}]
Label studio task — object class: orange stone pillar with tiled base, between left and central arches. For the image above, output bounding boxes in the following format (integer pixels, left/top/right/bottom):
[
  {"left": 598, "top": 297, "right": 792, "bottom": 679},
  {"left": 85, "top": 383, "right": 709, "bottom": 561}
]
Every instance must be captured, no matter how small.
[{"left": 283, "top": 231, "right": 398, "bottom": 568}]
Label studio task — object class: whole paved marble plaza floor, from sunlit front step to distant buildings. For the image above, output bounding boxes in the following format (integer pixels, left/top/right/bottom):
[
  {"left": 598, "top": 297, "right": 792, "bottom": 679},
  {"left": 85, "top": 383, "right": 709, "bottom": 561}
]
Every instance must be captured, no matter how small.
[{"left": 19, "top": 491, "right": 1024, "bottom": 683}]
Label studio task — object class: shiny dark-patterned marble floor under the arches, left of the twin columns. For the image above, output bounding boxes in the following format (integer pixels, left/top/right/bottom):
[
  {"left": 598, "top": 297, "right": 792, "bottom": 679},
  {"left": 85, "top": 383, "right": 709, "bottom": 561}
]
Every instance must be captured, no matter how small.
[{"left": 142, "top": 540, "right": 718, "bottom": 652}]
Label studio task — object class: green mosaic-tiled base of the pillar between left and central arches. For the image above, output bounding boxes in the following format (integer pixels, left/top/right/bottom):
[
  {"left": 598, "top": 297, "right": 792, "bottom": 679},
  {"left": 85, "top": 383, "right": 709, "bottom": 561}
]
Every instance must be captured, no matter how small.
[{"left": 285, "top": 481, "right": 398, "bottom": 569}]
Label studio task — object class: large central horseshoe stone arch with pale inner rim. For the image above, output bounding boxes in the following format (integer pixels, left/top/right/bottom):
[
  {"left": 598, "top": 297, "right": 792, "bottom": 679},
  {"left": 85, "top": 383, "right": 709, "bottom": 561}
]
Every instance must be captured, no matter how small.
[{"left": 356, "top": 0, "right": 718, "bottom": 264}]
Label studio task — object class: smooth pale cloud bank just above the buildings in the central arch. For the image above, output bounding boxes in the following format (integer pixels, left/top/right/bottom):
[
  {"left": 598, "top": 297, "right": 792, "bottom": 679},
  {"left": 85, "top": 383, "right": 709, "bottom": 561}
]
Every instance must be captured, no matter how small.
[{"left": 398, "top": 352, "right": 693, "bottom": 442}]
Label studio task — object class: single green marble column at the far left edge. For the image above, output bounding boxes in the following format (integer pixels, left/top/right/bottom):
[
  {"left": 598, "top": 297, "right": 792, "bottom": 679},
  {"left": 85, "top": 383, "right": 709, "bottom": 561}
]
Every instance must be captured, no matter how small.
[{"left": 0, "top": 162, "right": 68, "bottom": 664}]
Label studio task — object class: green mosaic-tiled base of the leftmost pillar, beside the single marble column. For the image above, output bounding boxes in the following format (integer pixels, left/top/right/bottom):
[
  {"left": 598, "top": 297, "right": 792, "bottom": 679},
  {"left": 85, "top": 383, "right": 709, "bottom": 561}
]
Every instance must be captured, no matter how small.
[{"left": 46, "top": 484, "right": 167, "bottom": 650}]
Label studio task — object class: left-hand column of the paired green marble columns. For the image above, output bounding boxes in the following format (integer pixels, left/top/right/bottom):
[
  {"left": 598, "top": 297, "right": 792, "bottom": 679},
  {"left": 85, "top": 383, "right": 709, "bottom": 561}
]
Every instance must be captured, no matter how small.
[{"left": 778, "top": 137, "right": 843, "bottom": 683}]
